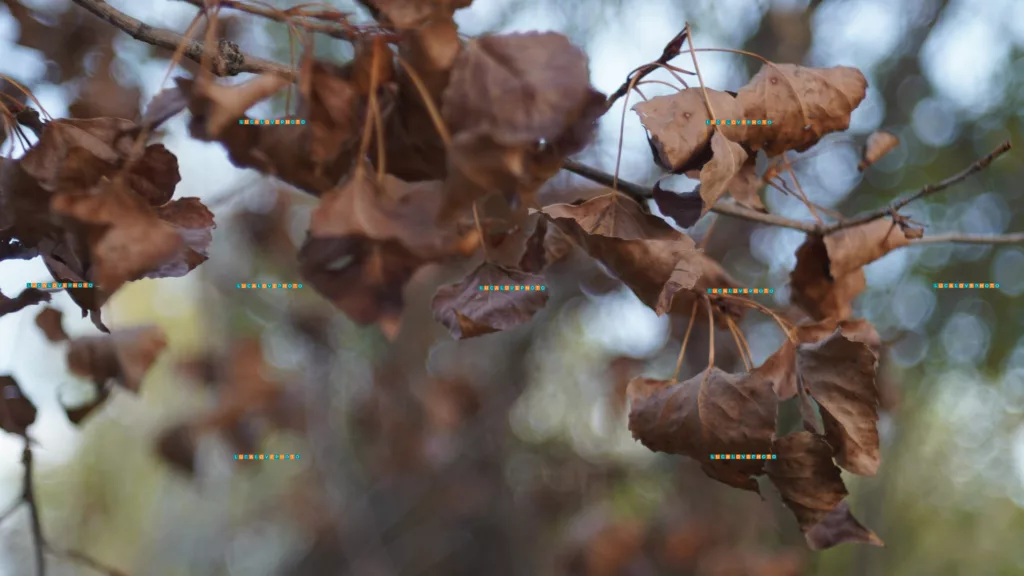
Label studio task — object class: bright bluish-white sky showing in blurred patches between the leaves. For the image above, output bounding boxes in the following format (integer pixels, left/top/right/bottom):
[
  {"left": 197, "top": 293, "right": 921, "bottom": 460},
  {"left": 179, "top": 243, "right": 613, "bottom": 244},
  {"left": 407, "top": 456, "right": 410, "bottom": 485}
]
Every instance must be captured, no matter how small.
[{"left": 0, "top": 0, "right": 1024, "bottom": 553}]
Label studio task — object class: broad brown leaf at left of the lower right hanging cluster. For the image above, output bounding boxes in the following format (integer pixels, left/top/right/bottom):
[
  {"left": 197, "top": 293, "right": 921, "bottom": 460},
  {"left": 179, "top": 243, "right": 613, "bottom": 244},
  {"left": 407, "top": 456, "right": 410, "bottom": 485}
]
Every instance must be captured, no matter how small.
[{"left": 627, "top": 368, "right": 777, "bottom": 492}]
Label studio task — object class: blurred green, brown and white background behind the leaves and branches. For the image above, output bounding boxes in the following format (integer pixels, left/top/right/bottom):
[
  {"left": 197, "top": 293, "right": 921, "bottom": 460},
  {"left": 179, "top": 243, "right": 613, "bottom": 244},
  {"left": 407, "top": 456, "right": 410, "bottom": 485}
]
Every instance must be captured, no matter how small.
[{"left": 0, "top": 0, "right": 1024, "bottom": 576}]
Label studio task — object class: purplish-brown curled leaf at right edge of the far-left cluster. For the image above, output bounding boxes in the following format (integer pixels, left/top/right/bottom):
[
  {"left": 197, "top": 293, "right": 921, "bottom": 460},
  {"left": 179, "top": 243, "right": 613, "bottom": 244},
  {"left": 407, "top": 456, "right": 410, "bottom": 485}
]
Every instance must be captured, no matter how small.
[{"left": 144, "top": 197, "right": 217, "bottom": 278}]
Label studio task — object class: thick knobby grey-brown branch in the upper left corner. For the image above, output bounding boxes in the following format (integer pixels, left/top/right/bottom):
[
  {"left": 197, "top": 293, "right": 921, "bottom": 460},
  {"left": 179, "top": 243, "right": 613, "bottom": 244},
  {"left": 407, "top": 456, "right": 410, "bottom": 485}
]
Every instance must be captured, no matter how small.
[{"left": 72, "top": 0, "right": 297, "bottom": 82}]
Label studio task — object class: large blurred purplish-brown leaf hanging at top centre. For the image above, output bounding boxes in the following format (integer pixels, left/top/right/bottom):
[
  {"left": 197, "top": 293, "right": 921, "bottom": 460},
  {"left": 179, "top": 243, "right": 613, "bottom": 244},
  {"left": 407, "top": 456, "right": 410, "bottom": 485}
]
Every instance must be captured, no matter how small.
[{"left": 441, "top": 33, "right": 604, "bottom": 217}]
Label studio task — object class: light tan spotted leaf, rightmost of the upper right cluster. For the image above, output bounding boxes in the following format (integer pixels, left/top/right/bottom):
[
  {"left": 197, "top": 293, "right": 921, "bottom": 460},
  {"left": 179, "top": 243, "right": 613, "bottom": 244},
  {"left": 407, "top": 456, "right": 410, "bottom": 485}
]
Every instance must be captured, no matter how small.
[{"left": 736, "top": 64, "right": 867, "bottom": 157}]
